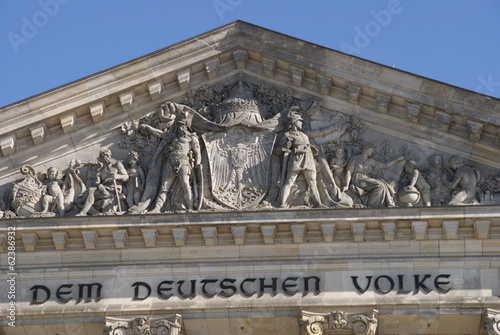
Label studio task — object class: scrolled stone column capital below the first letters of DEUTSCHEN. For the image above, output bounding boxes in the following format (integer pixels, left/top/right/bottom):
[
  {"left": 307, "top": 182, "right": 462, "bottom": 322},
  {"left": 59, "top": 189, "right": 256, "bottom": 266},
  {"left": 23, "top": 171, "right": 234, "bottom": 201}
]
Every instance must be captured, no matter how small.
[{"left": 104, "top": 314, "right": 182, "bottom": 335}]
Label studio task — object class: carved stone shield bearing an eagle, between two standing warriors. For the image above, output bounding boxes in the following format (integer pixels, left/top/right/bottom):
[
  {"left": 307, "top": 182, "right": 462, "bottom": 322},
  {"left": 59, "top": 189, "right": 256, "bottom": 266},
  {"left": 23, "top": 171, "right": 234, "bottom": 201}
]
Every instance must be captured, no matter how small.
[{"left": 203, "top": 126, "right": 276, "bottom": 209}]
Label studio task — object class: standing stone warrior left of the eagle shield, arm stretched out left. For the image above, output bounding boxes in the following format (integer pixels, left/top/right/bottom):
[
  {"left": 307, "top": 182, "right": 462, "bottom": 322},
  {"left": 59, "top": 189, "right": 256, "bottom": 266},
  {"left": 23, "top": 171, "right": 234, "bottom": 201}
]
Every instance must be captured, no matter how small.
[{"left": 142, "top": 119, "right": 201, "bottom": 213}]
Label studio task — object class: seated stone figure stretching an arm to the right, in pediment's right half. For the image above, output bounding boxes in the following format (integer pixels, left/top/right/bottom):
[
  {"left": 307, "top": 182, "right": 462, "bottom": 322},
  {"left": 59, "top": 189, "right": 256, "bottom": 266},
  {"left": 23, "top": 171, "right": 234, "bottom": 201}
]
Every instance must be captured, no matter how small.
[{"left": 343, "top": 145, "right": 405, "bottom": 208}]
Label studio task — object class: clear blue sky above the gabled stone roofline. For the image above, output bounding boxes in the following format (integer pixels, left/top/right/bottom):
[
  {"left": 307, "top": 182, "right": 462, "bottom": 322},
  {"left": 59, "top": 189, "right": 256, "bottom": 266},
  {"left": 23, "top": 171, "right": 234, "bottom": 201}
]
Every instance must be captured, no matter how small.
[{"left": 0, "top": 0, "right": 500, "bottom": 106}]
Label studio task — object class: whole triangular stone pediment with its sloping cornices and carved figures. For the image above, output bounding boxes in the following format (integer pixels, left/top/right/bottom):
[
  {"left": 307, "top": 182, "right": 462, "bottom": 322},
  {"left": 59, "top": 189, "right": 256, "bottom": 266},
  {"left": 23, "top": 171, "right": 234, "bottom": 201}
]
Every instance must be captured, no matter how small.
[{"left": 0, "top": 22, "right": 500, "bottom": 218}]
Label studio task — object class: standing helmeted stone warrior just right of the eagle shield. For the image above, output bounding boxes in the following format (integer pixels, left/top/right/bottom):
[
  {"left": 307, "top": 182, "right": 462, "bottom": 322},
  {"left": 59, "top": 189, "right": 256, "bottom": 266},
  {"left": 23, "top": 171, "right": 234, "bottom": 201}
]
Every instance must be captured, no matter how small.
[{"left": 278, "top": 107, "right": 323, "bottom": 207}]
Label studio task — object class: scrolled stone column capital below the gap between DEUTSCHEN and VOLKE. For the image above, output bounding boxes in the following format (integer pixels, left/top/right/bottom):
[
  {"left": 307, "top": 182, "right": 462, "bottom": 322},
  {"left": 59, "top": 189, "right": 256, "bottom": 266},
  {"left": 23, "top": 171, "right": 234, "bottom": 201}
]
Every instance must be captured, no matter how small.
[{"left": 299, "top": 309, "right": 378, "bottom": 335}]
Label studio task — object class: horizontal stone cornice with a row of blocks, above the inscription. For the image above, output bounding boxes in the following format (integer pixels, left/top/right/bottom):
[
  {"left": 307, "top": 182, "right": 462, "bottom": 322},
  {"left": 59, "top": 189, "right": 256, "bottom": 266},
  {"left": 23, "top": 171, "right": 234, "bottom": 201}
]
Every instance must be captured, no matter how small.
[{"left": 0, "top": 206, "right": 500, "bottom": 256}]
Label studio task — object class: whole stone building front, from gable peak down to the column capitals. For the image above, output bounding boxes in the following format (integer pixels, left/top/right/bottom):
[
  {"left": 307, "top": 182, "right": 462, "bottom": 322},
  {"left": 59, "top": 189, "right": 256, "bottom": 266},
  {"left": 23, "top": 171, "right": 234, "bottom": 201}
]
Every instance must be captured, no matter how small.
[{"left": 0, "top": 21, "right": 500, "bottom": 335}]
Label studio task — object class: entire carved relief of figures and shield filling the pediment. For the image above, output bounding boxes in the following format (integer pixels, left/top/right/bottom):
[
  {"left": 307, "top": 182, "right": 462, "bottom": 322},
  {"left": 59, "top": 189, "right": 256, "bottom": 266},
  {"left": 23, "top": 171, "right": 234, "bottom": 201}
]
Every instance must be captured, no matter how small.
[{"left": 0, "top": 80, "right": 500, "bottom": 218}]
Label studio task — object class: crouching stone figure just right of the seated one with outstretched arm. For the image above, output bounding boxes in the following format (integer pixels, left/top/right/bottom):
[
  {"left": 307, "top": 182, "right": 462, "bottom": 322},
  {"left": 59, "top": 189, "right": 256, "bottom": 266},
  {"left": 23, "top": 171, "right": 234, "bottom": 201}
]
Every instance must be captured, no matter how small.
[{"left": 398, "top": 160, "right": 431, "bottom": 207}]
